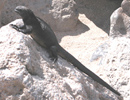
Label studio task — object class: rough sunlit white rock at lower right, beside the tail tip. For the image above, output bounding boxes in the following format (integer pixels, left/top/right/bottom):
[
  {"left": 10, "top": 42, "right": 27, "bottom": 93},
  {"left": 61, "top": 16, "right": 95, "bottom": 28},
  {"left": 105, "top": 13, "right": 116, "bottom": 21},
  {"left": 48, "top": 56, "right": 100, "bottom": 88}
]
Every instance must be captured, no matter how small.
[{"left": 100, "top": 37, "right": 130, "bottom": 100}]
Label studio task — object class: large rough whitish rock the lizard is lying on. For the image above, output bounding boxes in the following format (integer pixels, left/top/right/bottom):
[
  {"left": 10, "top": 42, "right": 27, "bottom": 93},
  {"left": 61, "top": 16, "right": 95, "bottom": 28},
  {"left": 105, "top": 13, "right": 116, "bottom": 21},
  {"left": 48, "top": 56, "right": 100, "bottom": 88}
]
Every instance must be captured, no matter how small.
[{"left": 0, "top": 20, "right": 120, "bottom": 100}]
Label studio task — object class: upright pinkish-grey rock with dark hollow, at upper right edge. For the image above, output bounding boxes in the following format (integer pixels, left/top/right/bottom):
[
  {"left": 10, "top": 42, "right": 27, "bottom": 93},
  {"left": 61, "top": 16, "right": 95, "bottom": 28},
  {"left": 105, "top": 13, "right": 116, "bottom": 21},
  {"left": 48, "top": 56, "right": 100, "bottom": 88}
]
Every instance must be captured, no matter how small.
[{"left": 110, "top": 0, "right": 130, "bottom": 37}]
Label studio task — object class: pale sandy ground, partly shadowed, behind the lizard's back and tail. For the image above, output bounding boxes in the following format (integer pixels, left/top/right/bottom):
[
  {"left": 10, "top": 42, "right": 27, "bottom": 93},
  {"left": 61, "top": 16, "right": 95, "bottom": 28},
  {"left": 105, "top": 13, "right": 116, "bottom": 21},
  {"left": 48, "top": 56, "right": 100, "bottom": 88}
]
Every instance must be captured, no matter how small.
[{"left": 56, "top": 14, "right": 108, "bottom": 73}]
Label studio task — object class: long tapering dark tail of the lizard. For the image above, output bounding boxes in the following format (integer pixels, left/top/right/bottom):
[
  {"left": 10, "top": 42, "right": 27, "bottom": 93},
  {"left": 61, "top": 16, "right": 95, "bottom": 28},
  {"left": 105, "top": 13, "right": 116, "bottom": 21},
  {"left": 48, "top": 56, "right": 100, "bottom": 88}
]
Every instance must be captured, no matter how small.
[{"left": 58, "top": 46, "right": 121, "bottom": 96}]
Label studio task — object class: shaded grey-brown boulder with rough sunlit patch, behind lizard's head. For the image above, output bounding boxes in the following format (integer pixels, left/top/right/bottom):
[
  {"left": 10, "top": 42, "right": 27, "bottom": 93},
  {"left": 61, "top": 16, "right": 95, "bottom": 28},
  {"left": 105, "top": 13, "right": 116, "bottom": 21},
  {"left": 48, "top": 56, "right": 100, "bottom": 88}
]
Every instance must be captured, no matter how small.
[{"left": 0, "top": 0, "right": 78, "bottom": 31}]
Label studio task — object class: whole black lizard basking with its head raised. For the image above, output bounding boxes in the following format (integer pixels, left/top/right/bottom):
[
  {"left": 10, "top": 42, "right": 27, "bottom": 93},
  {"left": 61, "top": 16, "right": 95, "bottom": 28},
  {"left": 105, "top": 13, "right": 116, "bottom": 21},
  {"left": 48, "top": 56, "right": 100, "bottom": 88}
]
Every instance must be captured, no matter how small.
[{"left": 11, "top": 6, "right": 121, "bottom": 96}]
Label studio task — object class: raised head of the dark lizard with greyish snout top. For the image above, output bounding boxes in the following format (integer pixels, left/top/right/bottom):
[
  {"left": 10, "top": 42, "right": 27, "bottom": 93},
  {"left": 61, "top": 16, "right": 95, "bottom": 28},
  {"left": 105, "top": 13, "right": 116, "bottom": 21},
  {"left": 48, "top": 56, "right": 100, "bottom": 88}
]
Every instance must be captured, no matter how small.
[{"left": 15, "top": 6, "right": 34, "bottom": 19}]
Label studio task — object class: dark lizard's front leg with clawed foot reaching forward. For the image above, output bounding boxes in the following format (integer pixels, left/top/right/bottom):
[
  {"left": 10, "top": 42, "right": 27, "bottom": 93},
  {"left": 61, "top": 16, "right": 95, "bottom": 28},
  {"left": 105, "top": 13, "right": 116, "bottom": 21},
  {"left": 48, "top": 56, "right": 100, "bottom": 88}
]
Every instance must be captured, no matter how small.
[{"left": 10, "top": 24, "right": 33, "bottom": 34}]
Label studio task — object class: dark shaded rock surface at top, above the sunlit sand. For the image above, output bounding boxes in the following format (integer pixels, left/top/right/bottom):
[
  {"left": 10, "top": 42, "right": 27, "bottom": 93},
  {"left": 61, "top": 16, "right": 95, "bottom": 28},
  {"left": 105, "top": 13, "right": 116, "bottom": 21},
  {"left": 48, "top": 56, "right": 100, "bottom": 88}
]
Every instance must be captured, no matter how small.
[{"left": 76, "top": 0, "right": 122, "bottom": 33}]
